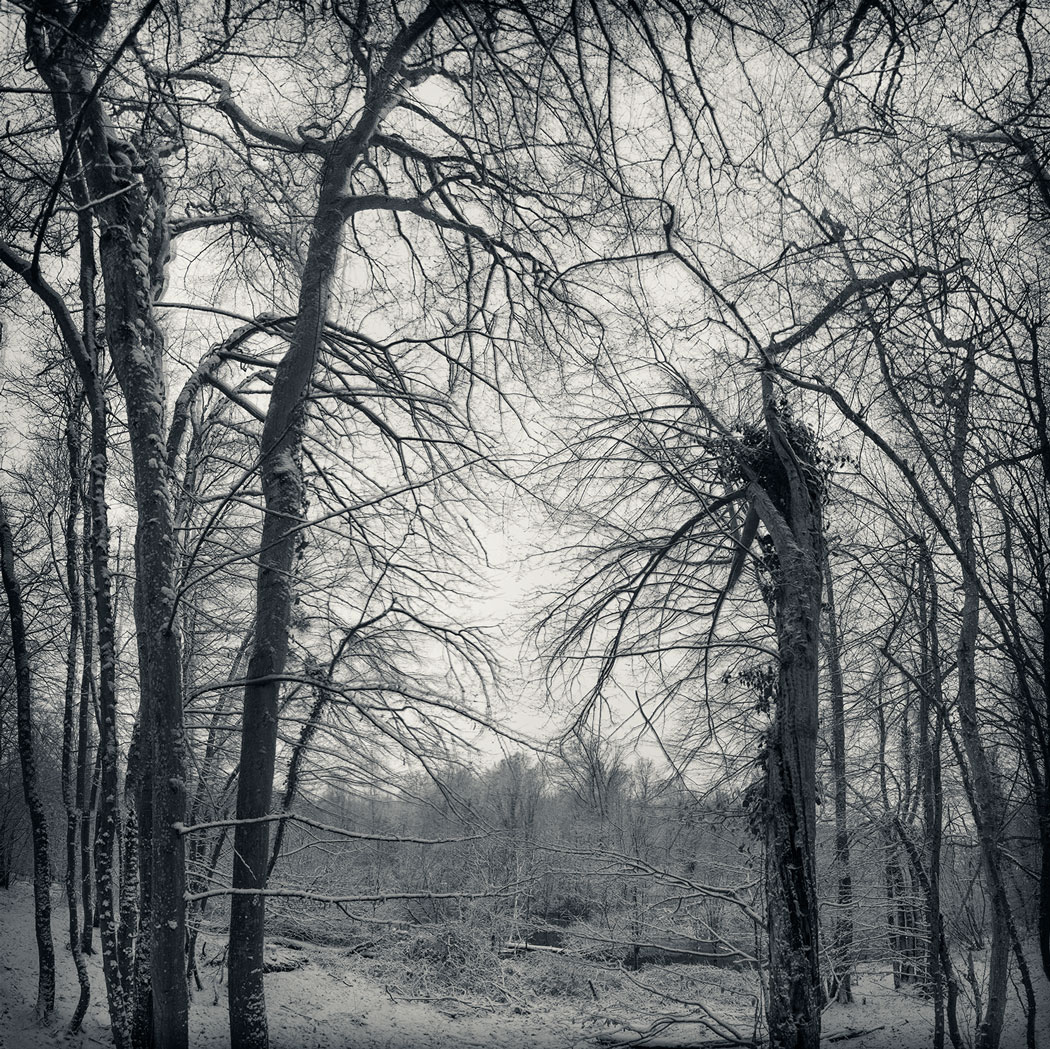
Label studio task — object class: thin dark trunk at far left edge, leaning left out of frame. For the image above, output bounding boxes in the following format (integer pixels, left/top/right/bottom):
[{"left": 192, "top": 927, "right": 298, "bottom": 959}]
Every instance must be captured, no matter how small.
[{"left": 0, "top": 498, "right": 55, "bottom": 1024}]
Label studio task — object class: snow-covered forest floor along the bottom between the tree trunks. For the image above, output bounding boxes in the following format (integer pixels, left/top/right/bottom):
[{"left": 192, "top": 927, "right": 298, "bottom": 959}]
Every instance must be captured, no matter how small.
[{"left": 0, "top": 883, "right": 1050, "bottom": 1049}]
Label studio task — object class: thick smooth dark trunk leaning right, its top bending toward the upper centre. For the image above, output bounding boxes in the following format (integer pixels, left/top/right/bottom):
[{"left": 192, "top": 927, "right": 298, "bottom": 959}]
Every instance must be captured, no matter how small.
[{"left": 229, "top": 10, "right": 442, "bottom": 1049}]
